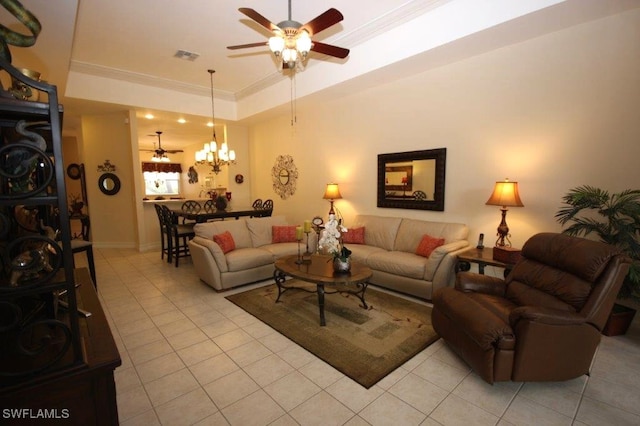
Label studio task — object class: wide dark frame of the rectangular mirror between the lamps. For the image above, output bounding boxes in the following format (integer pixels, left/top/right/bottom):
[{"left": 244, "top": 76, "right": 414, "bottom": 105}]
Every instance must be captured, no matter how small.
[{"left": 378, "top": 148, "right": 447, "bottom": 211}]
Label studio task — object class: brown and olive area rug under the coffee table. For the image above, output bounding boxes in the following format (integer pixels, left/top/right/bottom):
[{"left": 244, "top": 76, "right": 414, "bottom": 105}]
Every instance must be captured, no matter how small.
[{"left": 226, "top": 280, "right": 439, "bottom": 389}]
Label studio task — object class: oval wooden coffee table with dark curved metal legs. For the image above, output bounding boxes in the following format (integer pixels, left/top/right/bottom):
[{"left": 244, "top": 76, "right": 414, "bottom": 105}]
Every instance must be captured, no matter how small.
[{"left": 273, "top": 255, "right": 373, "bottom": 326}]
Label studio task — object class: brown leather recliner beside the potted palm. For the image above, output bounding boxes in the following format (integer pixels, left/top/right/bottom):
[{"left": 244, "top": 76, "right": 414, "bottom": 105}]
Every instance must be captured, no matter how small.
[{"left": 432, "top": 233, "right": 630, "bottom": 383}]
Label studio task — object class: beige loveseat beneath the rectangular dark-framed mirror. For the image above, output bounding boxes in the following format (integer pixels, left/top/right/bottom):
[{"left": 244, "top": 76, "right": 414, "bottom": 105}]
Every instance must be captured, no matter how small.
[{"left": 345, "top": 215, "right": 469, "bottom": 300}]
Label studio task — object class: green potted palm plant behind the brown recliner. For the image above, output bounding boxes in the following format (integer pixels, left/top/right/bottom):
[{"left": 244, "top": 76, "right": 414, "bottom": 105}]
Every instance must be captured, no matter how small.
[{"left": 555, "top": 185, "right": 640, "bottom": 336}]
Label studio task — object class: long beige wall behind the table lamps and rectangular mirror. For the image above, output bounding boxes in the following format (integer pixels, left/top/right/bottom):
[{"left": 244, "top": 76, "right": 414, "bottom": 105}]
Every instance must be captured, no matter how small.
[{"left": 249, "top": 11, "right": 640, "bottom": 247}]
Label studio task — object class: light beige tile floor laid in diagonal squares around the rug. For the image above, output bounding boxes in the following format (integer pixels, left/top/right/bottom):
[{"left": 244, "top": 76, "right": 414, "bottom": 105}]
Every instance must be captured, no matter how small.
[{"left": 85, "top": 249, "right": 640, "bottom": 426}]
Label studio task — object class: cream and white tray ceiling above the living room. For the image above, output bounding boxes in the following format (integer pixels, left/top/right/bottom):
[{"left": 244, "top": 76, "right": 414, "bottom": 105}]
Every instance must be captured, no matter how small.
[{"left": 0, "top": 0, "right": 640, "bottom": 149}]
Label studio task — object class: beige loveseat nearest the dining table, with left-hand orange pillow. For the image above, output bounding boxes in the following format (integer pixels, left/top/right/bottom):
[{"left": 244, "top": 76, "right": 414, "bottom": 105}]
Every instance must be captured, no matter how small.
[{"left": 189, "top": 216, "right": 315, "bottom": 290}]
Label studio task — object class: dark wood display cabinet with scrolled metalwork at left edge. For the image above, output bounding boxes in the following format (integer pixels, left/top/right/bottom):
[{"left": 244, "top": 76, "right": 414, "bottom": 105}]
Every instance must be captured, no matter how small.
[{"left": 0, "top": 58, "right": 120, "bottom": 424}]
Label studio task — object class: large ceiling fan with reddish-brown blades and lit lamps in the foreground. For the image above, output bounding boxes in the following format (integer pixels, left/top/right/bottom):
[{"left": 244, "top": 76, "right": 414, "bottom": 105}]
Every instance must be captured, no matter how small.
[{"left": 227, "top": 0, "right": 349, "bottom": 69}]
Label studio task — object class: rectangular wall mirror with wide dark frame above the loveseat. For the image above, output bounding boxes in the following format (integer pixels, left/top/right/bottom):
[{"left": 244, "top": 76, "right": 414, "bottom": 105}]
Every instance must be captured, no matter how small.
[{"left": 378, "top": 148, "right": 447, "bottom": 211}]
